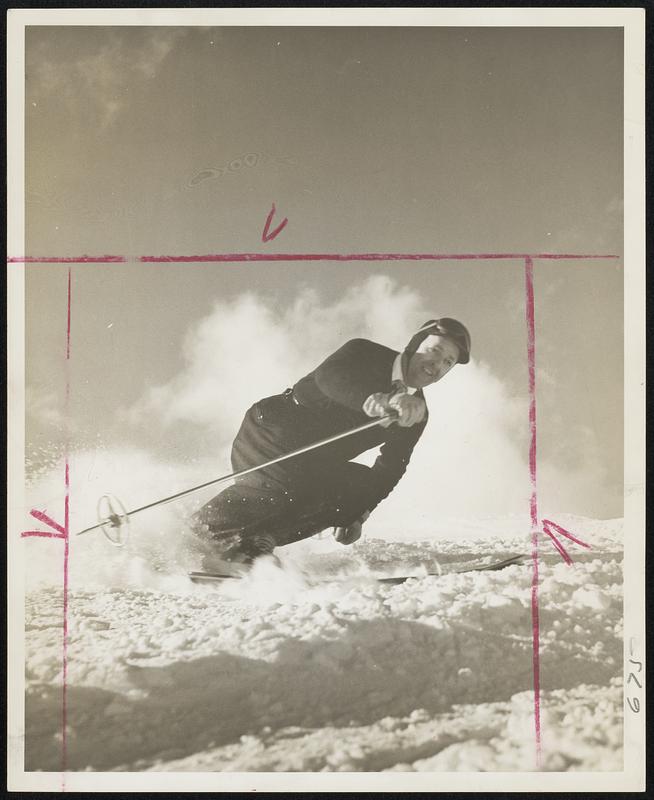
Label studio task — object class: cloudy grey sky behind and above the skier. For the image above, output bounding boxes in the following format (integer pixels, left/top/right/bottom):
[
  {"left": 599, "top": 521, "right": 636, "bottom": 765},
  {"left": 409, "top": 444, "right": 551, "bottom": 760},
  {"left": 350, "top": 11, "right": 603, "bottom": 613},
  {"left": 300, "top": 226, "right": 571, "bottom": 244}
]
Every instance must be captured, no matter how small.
[{"left": 25, "top": 26, "right": 623, "bottom": 525}]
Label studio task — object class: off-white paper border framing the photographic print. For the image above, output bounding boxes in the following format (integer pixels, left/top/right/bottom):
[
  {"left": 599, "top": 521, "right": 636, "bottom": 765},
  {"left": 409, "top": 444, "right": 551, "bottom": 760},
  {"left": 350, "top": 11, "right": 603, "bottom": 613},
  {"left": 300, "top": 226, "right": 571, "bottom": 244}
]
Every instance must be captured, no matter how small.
[{"left": 7, "top": 8, "right": 645, "bottom": 792}]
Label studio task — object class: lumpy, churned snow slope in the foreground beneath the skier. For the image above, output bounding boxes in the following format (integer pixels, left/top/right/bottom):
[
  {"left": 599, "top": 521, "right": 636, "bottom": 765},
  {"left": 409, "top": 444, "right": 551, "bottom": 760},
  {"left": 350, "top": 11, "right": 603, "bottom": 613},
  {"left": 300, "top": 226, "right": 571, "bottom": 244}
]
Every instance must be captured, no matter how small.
[{"left": 26, "top": 519, "right": 622, "bottom": 772}]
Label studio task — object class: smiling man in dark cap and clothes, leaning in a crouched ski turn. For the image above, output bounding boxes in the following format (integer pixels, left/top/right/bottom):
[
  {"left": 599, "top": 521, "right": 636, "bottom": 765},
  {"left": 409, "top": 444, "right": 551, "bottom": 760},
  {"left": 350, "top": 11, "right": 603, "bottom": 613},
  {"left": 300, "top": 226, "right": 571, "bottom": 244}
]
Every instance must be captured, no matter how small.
[{"left": 195, "top": 317, "right": 470, "bottom": 569}]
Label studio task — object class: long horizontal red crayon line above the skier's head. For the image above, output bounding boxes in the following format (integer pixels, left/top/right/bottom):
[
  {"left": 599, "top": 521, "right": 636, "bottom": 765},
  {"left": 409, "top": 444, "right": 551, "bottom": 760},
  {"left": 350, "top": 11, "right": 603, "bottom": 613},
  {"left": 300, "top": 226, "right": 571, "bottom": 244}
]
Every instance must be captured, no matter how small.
[{"left": 7, "top": 253, "right": 620, "bottom": 264}]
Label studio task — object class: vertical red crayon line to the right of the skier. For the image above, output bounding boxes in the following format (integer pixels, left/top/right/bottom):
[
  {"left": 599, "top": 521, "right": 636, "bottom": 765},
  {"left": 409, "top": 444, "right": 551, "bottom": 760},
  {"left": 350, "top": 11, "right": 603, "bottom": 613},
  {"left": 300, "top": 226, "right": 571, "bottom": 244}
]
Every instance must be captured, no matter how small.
[{"left": 525, "top": 256, "right": 541, "bottom": 769}]
